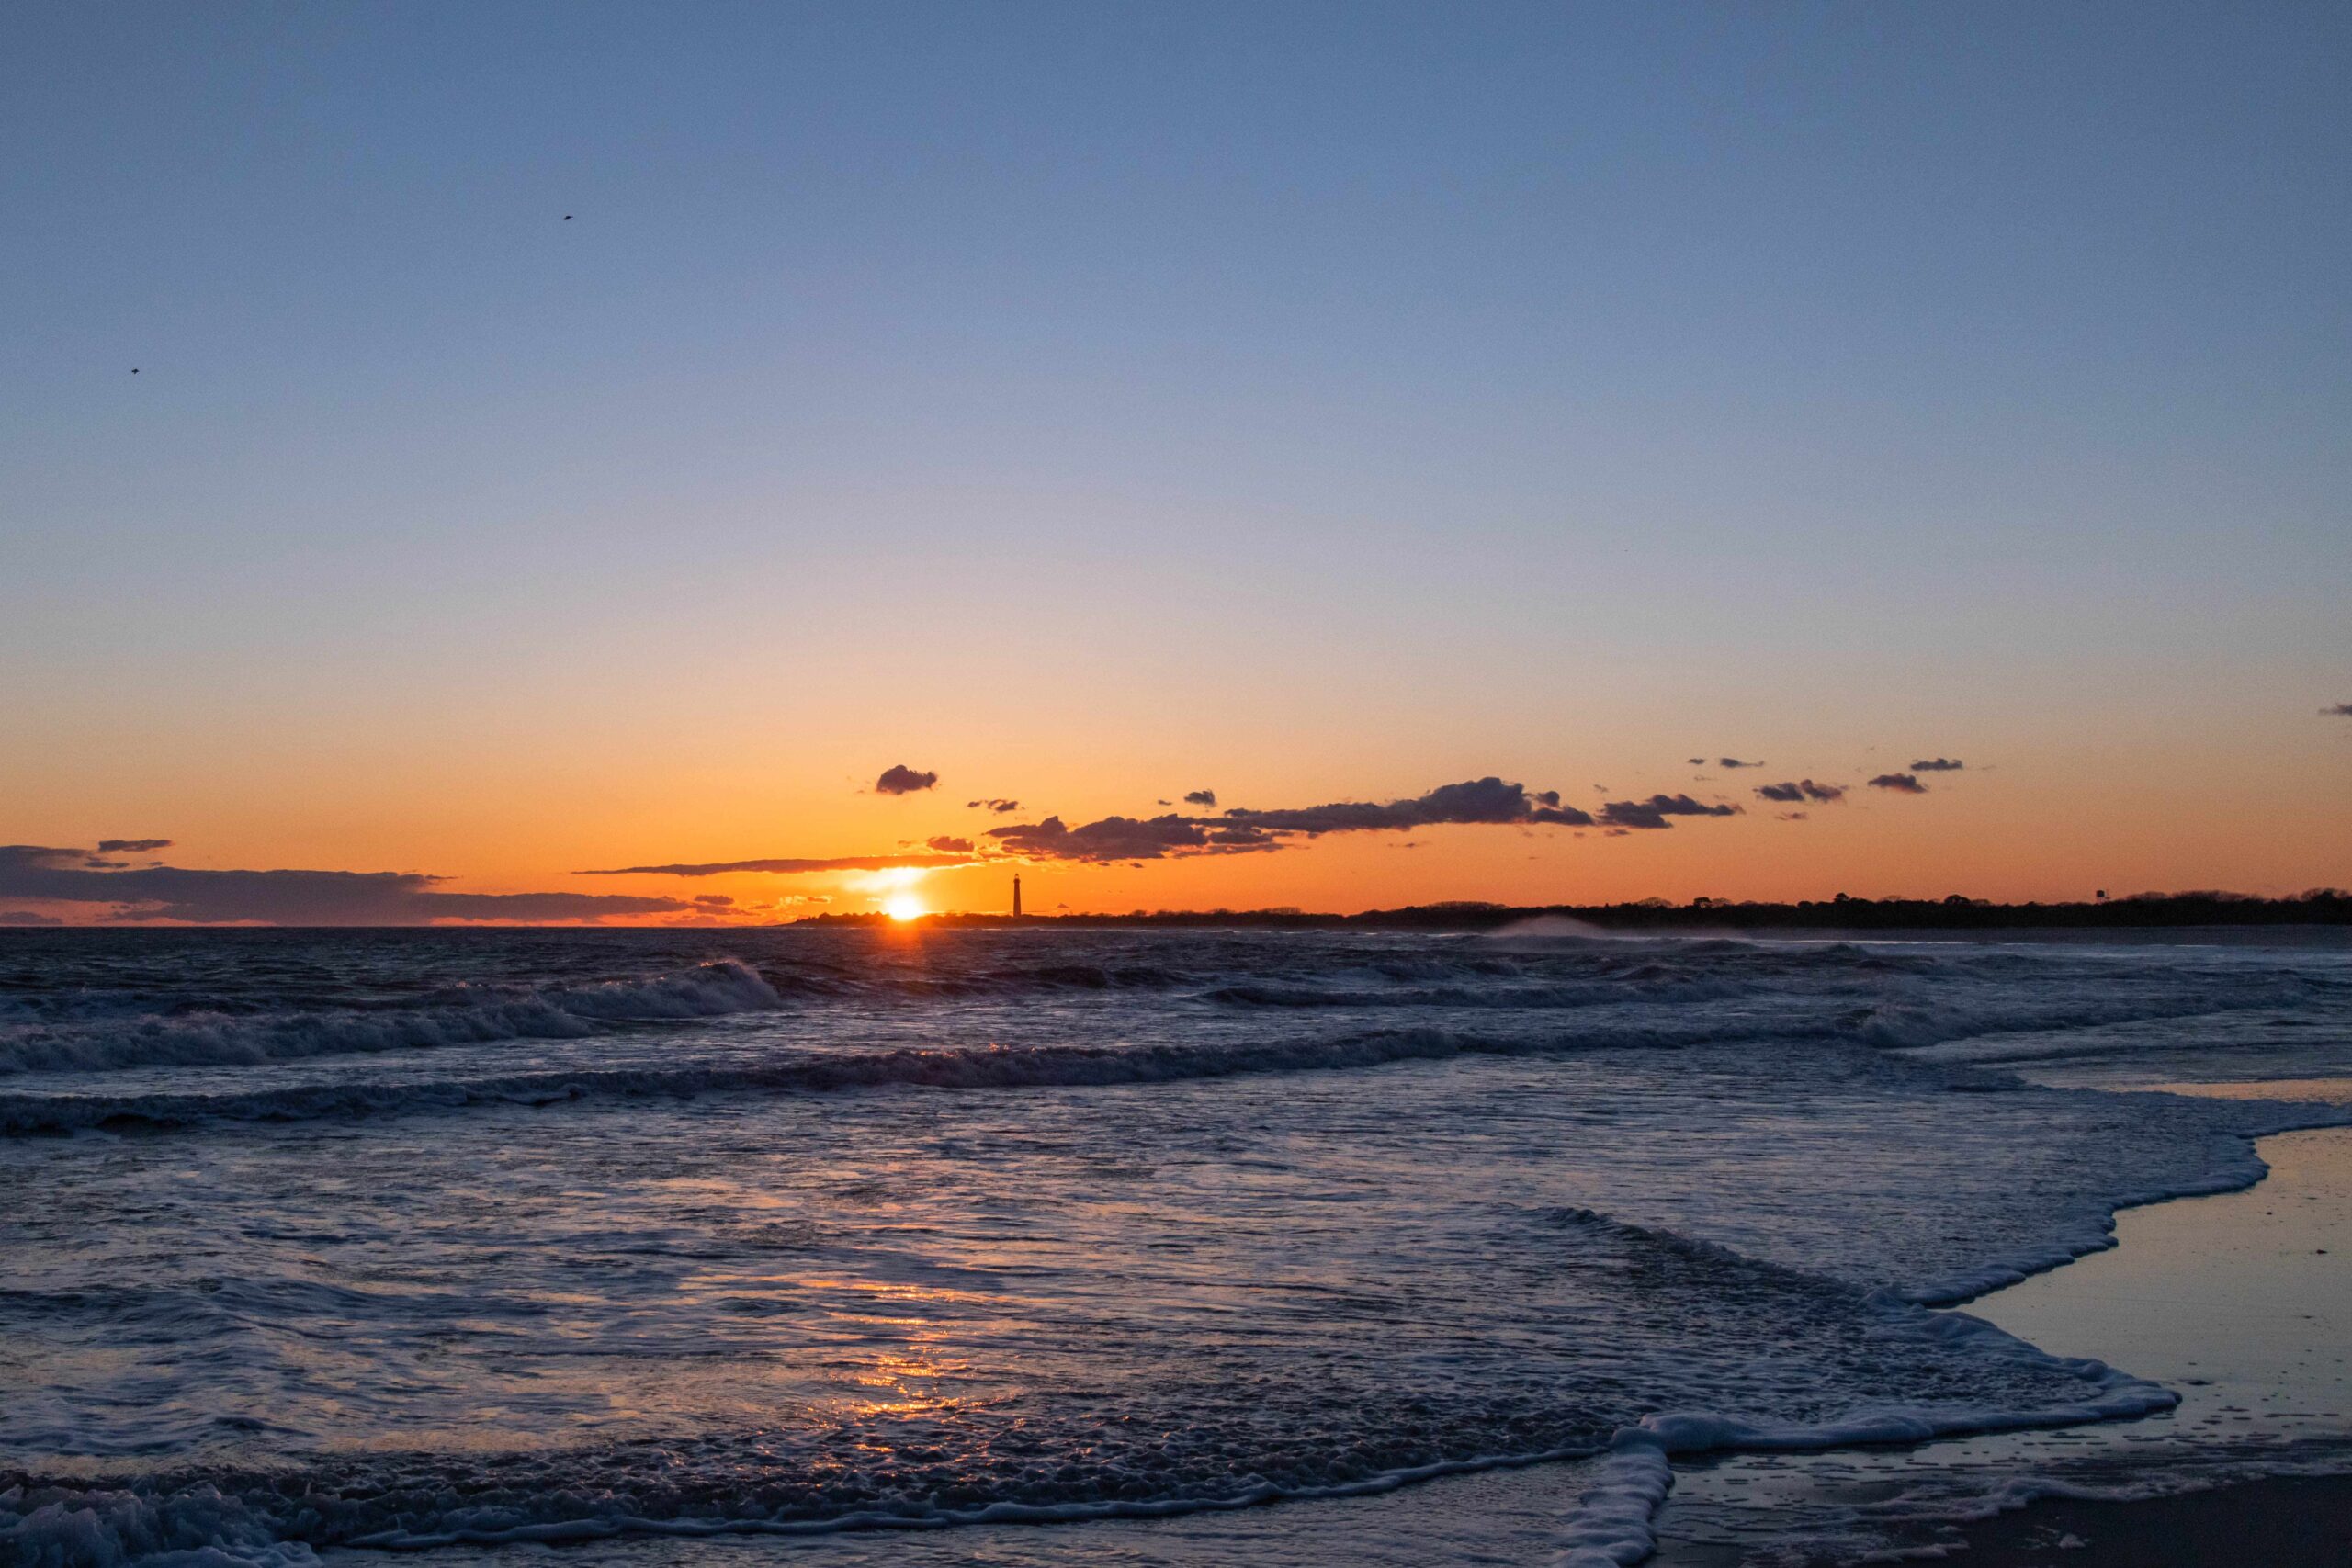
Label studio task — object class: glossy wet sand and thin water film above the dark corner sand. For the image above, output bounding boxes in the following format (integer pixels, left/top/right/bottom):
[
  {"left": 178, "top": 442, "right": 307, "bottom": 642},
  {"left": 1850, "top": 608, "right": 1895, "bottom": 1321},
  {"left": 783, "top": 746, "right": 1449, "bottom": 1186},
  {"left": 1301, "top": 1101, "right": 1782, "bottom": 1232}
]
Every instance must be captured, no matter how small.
[{"left": 1658, "top": 1128, "right": 2352, "bottom": 1568}]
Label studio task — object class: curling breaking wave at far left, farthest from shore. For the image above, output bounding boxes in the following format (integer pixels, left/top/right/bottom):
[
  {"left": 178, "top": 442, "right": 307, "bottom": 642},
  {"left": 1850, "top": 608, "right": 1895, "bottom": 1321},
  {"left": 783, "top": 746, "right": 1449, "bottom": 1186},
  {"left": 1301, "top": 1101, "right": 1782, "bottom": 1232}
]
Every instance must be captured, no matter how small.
[{"left": 0, "top": 959, "right": 783, "bottom": 1075}]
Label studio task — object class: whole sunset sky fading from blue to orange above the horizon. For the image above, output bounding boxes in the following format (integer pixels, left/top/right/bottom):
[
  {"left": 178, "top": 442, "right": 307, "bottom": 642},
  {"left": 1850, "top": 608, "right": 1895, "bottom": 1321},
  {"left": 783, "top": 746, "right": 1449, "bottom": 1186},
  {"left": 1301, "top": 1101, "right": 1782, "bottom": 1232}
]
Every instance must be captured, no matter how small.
[{"left": 0, "top": 0, "right": 2352, "bottom": 924}]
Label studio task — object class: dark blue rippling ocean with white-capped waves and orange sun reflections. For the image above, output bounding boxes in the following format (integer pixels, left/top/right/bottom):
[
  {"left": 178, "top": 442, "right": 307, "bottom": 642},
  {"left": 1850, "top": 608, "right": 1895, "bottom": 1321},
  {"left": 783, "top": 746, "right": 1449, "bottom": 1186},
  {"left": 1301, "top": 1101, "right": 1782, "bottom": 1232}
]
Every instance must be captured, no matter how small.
[{"left": 0, "top": 929, "right": 2352, "bottom": 1568}]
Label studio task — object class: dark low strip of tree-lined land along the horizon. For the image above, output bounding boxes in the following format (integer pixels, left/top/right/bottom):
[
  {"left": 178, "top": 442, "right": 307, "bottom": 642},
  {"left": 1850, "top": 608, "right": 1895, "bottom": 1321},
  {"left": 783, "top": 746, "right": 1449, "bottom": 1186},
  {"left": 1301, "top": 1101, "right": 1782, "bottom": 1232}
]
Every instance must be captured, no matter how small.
[{"left": 793, "top": 888, "right": 2352, "bottom": 931}]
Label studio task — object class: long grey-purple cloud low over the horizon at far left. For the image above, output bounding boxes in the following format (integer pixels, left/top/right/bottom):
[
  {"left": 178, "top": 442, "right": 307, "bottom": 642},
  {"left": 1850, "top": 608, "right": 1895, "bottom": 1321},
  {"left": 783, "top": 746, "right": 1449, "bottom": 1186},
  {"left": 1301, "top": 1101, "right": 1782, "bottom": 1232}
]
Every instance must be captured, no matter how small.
[{"left": 0, "top": 844, "right": 692, "bottom": 926}]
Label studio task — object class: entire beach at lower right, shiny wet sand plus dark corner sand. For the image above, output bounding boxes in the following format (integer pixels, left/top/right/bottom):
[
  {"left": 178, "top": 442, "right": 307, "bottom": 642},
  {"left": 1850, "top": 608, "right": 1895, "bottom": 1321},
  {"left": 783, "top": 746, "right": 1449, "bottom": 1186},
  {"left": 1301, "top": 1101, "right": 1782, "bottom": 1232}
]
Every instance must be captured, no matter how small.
[{"left": 1651, "top": 1109, "right": 2352, "bottom": 1568}]
